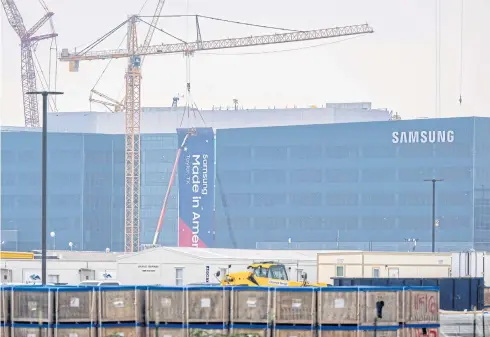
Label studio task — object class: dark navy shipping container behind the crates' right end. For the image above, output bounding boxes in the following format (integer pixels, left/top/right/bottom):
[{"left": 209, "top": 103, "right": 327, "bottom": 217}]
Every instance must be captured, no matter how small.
[{"left": 334, "top": 277, "right": 484, "bottom": 311}]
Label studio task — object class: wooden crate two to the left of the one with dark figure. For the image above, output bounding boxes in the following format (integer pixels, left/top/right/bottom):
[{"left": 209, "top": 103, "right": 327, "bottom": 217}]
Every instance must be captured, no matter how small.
[{"left": 273, "top": 287, "right": 318, "bottom": 337}]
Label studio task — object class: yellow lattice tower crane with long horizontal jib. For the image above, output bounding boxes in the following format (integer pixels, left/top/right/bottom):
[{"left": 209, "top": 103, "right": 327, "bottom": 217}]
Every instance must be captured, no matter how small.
[{"left": 59, "top": 15, "right": 374, "bottom": 252}]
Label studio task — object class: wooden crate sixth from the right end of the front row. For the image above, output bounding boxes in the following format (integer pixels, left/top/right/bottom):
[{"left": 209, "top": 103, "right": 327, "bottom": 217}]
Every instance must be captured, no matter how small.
[{"left": 185, "top": 286, "right": 230, "bottom": 337}]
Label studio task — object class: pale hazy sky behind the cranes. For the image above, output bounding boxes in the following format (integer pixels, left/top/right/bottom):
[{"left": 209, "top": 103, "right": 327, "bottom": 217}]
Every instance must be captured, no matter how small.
[{"left": 0, "top": 0, "right": 490, "bottom": 125}]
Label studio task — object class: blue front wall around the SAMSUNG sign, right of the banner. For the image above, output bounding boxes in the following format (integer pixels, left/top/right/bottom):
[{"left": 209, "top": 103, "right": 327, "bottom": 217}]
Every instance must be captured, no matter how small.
[{"left": 216, "top": 118, "right": 474, "bottom": 250}]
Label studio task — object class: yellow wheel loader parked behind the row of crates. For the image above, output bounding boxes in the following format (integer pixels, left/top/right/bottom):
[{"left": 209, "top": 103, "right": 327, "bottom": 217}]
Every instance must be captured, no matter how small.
[{"left": 215, "top": 262, "right": 328, "bottom": 287}]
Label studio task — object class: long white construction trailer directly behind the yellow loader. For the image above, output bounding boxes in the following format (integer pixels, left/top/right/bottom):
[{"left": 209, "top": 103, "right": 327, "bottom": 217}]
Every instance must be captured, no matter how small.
[{"left": 117, "top": 247, "right": 318, "bottom": 286}]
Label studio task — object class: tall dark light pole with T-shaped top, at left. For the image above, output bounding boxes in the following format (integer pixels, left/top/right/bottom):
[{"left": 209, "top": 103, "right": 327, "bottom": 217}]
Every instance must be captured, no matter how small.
[{"left": 27, "top": 91, "right": 63, "bottom": 286}]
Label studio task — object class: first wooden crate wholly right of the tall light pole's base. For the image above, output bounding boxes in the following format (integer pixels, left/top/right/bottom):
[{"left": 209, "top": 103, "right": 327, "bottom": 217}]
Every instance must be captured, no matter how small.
[{"left": 54, "top": 287, "right": 97, "bottom": 337}]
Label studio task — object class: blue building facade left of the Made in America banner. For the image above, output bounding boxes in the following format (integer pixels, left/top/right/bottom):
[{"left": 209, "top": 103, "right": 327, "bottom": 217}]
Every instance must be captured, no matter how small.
[{"left": 0, "top": 129, "right": 178, "bottom": 251}]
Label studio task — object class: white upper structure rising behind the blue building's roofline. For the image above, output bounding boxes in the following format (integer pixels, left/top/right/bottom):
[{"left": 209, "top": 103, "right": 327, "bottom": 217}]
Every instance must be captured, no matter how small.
[{"left": 32, "top": 103, "right": 391, "bottom": 134}]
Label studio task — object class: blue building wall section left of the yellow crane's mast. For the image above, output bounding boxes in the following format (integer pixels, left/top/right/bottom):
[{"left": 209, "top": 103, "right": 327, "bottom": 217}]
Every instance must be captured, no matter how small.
[{"left": 1, "top": 132, "right": 124, "bottom": 251}]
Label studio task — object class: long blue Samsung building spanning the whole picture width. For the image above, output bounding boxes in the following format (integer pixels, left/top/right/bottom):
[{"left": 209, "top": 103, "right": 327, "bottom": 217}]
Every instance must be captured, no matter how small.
[{"left": 1, "top": 111, "right": 490, "bottom": 251}]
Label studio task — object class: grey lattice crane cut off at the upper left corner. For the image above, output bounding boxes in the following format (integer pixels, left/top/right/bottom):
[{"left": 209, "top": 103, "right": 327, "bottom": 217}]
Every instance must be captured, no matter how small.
[{"left": 1, "top": 0, "right": 58, "bottom": 128}]
